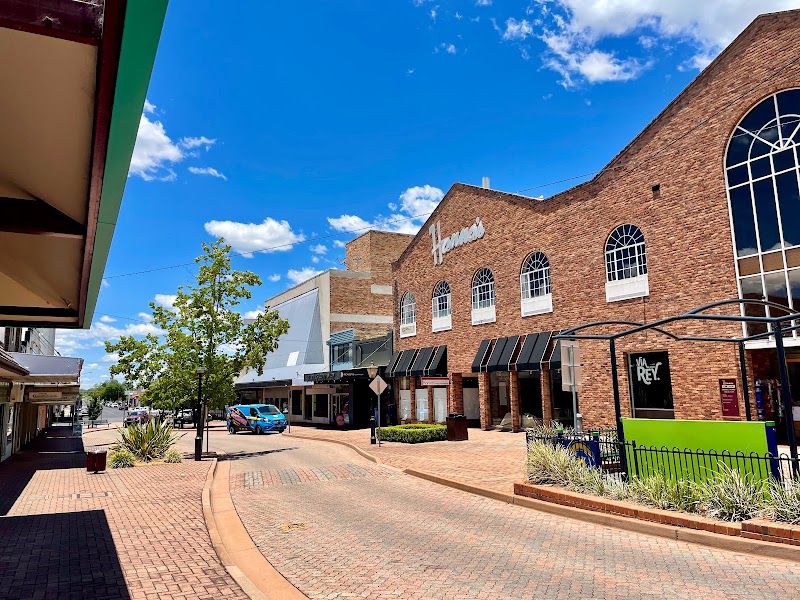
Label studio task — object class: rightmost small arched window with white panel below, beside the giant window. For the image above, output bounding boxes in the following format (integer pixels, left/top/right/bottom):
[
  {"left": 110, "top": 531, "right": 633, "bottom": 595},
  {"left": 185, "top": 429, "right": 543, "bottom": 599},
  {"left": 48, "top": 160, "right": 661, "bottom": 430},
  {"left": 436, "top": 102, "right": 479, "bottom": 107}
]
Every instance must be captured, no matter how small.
[{"left": 606, "top": 224, "right": 650, "bottom": 302}]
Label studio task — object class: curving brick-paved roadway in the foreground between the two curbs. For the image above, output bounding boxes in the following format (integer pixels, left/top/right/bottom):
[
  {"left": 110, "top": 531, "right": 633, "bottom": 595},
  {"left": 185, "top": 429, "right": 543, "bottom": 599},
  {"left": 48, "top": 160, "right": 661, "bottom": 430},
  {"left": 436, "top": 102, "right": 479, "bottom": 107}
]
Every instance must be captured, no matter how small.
[{"left": 231, "top": 437, "right": 800, "bottom": 600}]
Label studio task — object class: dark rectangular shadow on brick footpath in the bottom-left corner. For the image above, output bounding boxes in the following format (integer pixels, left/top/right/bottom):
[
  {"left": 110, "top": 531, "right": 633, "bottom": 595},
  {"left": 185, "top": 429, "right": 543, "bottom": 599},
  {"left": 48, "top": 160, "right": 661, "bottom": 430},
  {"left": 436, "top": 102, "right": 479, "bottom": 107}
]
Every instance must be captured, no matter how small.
[{"left": 0, "top": 510, "right": 130, "bottom": 600}]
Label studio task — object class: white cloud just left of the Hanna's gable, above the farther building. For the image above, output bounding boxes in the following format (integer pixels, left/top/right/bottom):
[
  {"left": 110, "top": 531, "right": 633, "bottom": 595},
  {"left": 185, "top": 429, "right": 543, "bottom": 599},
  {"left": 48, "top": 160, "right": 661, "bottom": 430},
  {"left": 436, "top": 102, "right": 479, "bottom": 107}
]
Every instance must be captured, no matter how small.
[{"left": 328, "top": 184, "right": 444, "bottom": 238}]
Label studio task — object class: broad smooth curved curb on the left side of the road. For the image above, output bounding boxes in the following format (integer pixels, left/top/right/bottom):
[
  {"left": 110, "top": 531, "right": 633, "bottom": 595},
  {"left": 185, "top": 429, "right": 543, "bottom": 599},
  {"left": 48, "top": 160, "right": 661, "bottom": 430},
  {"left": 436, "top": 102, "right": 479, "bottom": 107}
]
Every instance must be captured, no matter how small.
[{"left": 203, "top": 458, "right": 307, "bottom": 600}]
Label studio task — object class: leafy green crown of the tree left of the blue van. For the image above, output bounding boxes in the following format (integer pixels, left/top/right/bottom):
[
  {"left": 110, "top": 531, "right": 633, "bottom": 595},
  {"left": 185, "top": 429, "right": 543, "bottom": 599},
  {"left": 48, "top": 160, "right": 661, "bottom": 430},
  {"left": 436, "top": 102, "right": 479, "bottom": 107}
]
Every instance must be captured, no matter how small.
[{"left": 106, "top": 238, "right": 289, "bottom": 410}]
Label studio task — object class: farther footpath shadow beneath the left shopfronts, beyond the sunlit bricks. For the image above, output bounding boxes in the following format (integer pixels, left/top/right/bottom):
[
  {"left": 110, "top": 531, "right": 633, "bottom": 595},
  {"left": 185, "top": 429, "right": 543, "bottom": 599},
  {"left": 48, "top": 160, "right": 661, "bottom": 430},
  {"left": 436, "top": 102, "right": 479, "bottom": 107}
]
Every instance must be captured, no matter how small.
[{"left": 0, "top": 427, "right": 86, "bottom": 516}]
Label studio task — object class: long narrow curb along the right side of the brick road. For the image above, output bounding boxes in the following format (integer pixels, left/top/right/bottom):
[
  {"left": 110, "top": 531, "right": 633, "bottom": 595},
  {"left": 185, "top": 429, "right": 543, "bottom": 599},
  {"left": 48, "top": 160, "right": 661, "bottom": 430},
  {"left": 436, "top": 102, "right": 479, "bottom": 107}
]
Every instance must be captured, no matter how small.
[{"left": 284, "top": 434, "right": 800, "bottom": 562}]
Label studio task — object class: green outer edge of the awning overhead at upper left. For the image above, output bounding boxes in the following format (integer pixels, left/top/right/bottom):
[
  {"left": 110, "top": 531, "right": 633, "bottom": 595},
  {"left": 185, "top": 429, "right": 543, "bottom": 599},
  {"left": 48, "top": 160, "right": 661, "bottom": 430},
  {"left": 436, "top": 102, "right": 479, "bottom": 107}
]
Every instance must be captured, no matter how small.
[{"left": 83, "top": 0, "right": 169, "bottom": 329}]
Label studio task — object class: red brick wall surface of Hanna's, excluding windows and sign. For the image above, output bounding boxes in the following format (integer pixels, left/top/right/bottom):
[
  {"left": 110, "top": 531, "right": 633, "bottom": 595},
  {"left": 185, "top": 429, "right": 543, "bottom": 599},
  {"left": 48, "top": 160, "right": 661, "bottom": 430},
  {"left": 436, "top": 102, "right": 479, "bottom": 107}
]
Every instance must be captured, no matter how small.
[{"left": 394, "top": 13, "right": 800, "bottom": 426}]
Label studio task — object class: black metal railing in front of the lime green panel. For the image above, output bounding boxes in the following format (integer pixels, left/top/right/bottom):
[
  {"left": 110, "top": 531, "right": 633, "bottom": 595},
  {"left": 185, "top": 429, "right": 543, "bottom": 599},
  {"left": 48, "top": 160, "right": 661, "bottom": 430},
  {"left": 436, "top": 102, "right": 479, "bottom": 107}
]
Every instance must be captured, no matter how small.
[{"left": 526, "top": 429, "right": 800, "bottom": 482}]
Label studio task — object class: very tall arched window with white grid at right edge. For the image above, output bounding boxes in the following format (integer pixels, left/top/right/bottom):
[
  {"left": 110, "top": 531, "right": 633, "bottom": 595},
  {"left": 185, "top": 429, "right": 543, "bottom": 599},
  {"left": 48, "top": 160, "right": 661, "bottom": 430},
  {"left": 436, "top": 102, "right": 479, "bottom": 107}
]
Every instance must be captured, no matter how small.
[{"left": 725, "top": 89, "right": 800, "bottom": 336}]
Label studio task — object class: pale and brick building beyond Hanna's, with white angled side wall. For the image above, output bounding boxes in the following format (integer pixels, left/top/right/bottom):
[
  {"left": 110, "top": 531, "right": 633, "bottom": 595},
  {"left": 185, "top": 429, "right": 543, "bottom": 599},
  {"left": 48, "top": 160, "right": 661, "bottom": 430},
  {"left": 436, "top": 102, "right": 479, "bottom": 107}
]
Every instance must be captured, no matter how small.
[{"left": 236, "top": 231, "right": 412, "bottom": 426}]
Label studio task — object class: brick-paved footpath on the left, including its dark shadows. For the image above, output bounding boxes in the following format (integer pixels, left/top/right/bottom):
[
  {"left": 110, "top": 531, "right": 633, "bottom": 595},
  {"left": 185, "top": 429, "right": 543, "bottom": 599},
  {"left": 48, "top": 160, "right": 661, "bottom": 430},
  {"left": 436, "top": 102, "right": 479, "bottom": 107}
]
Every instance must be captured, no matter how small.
[{"left": 0, "top": 428, "right": 246, "bottom": 600}]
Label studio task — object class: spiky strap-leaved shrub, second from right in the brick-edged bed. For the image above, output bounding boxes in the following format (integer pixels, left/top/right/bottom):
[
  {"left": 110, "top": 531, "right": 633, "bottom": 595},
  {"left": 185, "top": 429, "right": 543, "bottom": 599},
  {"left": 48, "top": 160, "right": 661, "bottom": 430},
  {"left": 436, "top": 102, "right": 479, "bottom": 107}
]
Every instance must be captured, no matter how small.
[{"left": 700, "top": 463, "right": 768, "bottom": 521}]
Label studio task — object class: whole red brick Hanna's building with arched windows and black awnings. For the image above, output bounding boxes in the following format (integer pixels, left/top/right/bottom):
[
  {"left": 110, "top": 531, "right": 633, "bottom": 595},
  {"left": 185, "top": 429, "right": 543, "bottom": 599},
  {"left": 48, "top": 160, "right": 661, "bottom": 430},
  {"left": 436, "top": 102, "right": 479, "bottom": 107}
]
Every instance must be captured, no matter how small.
[{"left": 387, "top": 11, "right": 800, "bottom": 440}]
